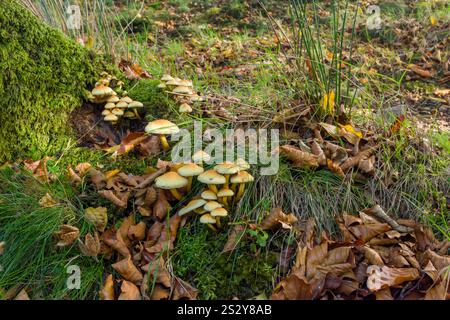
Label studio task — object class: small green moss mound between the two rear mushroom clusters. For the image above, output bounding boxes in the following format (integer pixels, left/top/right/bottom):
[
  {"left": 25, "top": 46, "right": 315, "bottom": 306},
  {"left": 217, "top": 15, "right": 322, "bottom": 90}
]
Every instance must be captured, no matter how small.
[{"left": 128, "top": 79, "right": 175, "bottom": 118}]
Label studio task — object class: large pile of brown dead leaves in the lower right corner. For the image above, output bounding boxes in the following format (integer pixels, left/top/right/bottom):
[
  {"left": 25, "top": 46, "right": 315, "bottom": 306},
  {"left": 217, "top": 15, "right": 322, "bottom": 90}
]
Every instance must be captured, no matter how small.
[{"left": 272, "top": 207, "right": 450, "bottom": 300}]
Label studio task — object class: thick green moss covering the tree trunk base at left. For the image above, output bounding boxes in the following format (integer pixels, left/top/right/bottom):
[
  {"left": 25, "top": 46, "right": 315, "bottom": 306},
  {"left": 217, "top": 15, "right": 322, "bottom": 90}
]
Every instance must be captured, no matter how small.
[{"left": 0, "top": 0, "right": 109, "bottom": 162}]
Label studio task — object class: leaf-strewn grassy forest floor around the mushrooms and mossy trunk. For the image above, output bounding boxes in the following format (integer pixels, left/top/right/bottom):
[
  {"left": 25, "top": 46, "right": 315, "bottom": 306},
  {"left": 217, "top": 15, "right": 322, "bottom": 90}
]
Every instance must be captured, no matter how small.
[{"left": 0, "top": 0, "right": 450, "bottom": 299}]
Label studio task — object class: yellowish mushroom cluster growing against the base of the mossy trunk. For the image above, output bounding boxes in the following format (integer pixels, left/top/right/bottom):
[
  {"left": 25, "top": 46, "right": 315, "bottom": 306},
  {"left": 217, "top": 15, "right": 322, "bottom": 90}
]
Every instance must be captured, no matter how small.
[{"left": 90, "top": 72, "right": 144, "bottom": 124}]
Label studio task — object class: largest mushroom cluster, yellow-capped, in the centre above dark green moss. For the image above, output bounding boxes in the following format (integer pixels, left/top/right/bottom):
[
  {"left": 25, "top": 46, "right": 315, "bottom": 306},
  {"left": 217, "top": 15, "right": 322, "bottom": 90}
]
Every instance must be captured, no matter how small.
[{"left": 175, "top": 151, "right": 253, "bottom": 231}]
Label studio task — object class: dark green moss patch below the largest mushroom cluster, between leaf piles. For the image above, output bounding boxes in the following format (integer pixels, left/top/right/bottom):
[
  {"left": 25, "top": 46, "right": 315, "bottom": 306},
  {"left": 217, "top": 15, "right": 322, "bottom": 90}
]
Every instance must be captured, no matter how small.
[{"left": 173, "top": 224, "right": 276, "bottom": 299}]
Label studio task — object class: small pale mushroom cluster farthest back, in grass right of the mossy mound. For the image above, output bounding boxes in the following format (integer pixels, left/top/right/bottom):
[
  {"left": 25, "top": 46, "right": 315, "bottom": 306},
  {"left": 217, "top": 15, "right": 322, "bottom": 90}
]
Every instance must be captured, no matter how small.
[{"left": 158, "top": 74, "right": 204, "bottom": 113}]
